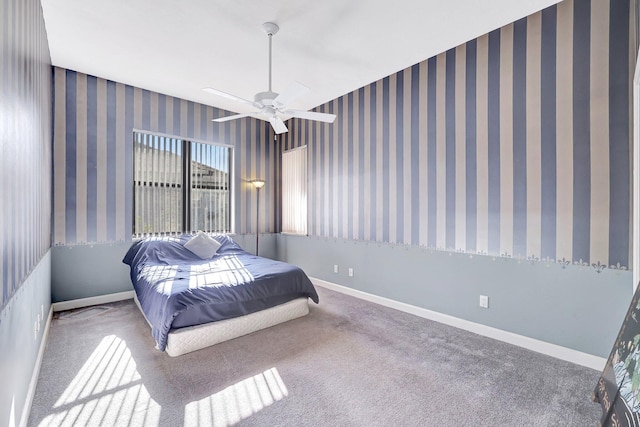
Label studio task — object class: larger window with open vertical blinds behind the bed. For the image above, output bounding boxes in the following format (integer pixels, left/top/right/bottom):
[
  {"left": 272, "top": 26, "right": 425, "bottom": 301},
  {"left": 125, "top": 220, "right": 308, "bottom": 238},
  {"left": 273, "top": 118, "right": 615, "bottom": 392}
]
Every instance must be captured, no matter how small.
[{"left": 133, "top": 132, "right": 233, "bottom": 237}]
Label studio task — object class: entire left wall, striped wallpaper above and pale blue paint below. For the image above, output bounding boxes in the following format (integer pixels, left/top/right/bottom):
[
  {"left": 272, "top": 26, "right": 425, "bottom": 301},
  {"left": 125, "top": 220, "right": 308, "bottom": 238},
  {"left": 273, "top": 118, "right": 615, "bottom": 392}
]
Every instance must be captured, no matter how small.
[{"left": 0, "top": 0, "right": 51, "bottom": 427}]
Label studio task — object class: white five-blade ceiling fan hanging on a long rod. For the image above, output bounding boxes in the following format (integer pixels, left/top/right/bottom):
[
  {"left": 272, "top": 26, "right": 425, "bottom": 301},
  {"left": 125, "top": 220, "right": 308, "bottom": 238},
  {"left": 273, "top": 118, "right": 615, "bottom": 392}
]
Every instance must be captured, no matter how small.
[{"left": 203, "top": 22, "right": 336, "bottom": 134}]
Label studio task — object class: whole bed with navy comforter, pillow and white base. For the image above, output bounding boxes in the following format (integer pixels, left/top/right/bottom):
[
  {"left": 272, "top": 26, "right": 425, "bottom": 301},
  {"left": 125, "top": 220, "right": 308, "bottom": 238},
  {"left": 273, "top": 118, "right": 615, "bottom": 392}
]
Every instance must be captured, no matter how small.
[{"left": 123, "top": 233, "right": 319, "bottom": 356}]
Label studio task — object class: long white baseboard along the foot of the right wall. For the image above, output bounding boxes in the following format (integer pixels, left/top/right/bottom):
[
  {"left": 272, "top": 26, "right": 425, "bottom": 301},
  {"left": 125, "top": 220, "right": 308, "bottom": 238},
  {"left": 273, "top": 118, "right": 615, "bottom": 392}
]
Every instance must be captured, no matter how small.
[{"left": 311, "top": 277, "right": 607, "bottom": 371}]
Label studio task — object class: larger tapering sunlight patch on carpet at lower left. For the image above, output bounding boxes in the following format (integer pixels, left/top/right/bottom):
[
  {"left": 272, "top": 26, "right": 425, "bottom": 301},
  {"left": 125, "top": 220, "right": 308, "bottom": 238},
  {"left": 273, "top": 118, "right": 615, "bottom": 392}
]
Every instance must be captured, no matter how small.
[{"left": 40, "top": 335, "right": 161, "bottom": 426}]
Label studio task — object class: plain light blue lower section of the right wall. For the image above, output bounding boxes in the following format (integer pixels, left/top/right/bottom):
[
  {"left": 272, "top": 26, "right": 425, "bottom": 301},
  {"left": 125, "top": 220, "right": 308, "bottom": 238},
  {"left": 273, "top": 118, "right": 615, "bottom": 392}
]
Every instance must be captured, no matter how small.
[{"left": 278, "top": 235, "right": 632, "bottom": 357}]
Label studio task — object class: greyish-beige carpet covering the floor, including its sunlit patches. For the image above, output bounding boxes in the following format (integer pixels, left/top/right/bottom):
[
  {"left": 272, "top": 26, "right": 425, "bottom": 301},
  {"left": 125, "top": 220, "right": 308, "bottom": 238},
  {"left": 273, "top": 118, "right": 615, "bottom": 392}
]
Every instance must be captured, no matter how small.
[{"left": 29, "top": 288, "right": 600, "bottom": 427}]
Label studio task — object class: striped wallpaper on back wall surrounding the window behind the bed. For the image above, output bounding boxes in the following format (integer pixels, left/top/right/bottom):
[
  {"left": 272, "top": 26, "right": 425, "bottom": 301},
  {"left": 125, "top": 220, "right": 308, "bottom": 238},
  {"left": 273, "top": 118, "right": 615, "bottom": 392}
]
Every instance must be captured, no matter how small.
[{"left": 53, "top": 67, "right": 280, "bottom": 245}]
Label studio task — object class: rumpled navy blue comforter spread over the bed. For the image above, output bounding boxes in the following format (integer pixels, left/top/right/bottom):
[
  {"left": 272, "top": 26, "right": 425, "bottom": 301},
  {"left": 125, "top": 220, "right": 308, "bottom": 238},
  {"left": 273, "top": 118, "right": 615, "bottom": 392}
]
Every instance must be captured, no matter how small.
[{"left": 123, "top": 236, "right": 318, "bottom": 351}]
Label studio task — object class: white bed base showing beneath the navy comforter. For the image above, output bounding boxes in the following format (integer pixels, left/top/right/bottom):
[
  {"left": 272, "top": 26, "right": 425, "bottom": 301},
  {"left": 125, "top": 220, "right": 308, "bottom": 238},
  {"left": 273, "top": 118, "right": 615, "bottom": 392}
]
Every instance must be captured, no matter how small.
[{"left": 133, "top": 296, "right": 309, "bottom": 357}]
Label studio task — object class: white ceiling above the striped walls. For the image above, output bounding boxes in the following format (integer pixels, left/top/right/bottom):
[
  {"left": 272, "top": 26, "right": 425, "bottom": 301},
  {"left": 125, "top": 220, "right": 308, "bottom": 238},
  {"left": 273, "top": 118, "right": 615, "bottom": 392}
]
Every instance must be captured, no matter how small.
[{"left": 42, "top": 0, "right": 559, "bottom": 117}]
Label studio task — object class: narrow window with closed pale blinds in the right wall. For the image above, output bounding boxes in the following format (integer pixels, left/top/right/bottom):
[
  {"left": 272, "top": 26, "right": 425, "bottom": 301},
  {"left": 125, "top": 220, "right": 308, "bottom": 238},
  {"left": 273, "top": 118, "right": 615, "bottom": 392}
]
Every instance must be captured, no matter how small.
[{"left": 282, "top": 145, "right": 307, "bottom": 235}]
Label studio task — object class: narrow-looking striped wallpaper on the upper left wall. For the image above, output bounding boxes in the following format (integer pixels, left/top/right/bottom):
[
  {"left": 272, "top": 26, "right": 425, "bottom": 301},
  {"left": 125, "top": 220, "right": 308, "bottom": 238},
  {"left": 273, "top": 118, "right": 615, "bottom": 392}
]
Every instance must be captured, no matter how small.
[{"left": 0, "top": 0, "right": 51, "bottom": 311}]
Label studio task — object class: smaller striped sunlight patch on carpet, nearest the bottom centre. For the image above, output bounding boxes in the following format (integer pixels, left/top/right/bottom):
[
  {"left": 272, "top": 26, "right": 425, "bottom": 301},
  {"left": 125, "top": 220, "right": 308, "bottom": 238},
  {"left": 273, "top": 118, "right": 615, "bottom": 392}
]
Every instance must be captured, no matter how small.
[{"left": 184, "top": 368, "right": 289, "bottom": 427}]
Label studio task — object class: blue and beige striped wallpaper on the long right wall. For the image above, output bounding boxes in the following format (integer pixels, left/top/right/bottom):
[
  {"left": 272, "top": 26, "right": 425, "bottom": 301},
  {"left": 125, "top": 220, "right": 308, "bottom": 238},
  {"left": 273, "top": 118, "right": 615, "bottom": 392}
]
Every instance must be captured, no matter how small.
[{"left": 282, "top": 0, "right": 636, "bottom": 268}]
